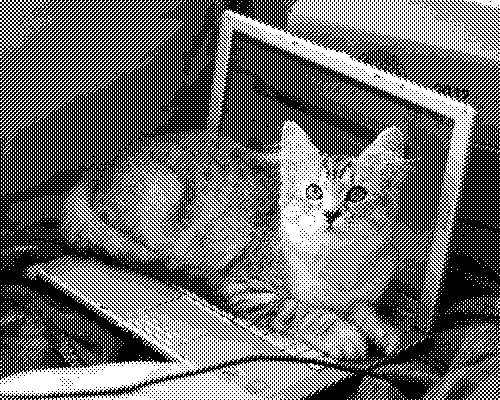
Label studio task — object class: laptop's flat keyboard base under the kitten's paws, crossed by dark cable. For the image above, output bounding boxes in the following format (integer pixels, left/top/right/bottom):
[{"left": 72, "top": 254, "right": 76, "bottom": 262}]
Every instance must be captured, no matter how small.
[{"left": 32, "top": 257, "right": 349, "bottom": 398}]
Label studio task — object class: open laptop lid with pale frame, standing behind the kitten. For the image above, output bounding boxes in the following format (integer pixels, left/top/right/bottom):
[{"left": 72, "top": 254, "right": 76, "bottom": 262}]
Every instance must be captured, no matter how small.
[{"left": 209, "top": 11, "right": 475, "bottom": 332}]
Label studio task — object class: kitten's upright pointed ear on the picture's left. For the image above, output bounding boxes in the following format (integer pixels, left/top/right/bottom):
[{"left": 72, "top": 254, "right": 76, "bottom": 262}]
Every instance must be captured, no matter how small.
[{"left": 280, "top": 121, "right": 320, "bottom": 161}]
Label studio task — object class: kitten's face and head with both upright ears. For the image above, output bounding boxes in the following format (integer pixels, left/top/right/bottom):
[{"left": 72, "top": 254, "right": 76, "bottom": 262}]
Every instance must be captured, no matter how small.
[{"left": 280, "top": 122, "right": 410, "bottom": 244}]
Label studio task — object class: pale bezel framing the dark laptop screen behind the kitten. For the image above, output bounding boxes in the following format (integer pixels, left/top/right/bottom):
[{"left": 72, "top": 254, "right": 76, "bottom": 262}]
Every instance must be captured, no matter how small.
[{"left": 208, "top": 11, "right": 475, "bottom": 332}]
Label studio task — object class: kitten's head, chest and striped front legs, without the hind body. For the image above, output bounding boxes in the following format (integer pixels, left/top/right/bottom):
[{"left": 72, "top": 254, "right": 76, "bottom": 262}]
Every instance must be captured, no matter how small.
[{"left": 220, "top": 121, "right": 413, "bottom": 358}]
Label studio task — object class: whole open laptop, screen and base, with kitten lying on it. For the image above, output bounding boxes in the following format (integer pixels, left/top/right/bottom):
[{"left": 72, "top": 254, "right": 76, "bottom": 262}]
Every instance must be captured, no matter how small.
[{"left": 29, "top": 11, "right": 474, "bottom": 399}]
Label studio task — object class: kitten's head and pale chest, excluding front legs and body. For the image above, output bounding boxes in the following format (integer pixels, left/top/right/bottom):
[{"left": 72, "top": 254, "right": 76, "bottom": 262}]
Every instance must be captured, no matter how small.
[{"left": 280, "top": 122, "right": 411, "bottom": 312}]
